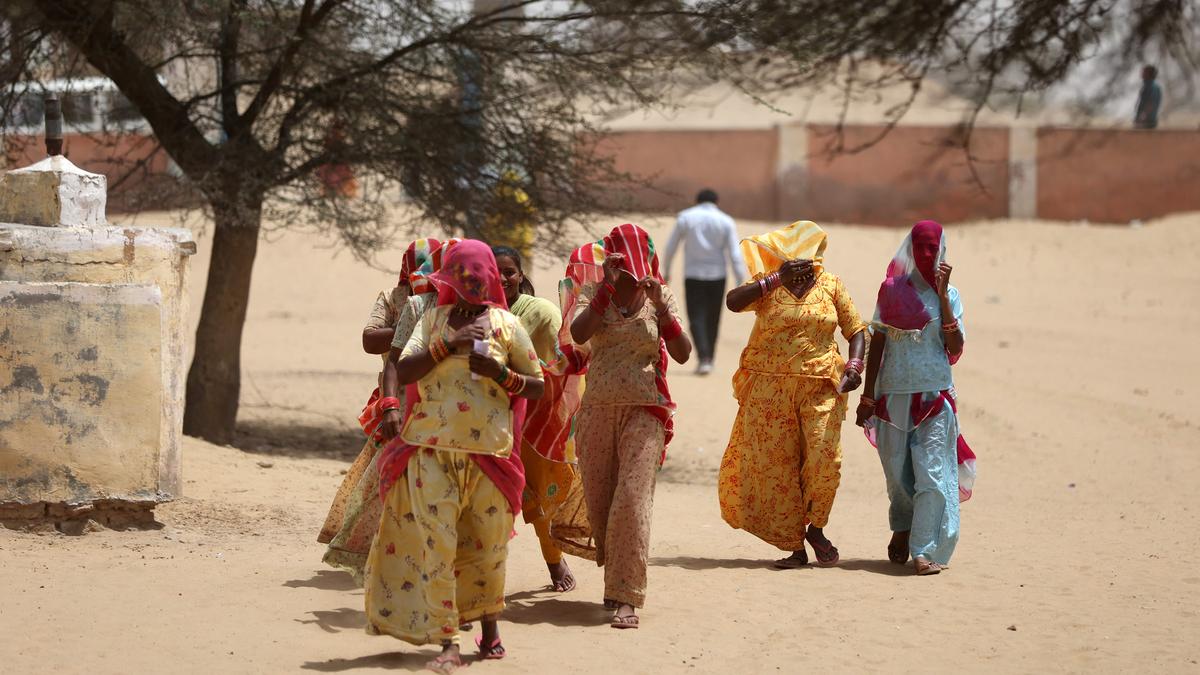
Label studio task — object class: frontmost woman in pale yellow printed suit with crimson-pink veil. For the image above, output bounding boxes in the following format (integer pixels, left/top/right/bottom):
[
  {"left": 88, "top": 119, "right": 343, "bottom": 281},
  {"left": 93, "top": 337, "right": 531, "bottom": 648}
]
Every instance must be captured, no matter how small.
[{"left": 366, "top": 240, "right": 542, "bottom": 671}]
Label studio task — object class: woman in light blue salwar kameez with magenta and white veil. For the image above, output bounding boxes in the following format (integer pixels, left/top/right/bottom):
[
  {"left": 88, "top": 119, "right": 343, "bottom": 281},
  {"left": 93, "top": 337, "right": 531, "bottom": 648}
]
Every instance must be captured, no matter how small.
[{"left": 857, "top": 221, "right": 974, "bottom": 575}]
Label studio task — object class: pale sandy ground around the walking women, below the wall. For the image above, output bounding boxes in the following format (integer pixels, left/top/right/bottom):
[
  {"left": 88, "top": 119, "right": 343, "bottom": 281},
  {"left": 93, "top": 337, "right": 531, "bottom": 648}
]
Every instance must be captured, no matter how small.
[{"left": 0, "top": 207, "right": 1200, "bottom": 674}]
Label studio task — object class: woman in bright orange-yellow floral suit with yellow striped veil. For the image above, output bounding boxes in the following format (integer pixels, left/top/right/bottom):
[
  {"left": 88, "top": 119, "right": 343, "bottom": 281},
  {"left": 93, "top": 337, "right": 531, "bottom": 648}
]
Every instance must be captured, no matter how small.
[{"left": 718, "top": 221, "right": 866, "bottom": 568}]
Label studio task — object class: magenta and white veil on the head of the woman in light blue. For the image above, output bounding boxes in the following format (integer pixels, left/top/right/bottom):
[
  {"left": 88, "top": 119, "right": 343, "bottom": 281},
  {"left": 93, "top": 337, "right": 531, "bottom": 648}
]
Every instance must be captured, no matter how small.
[{"left": 875, "top": 220, "right": 946, "bottom": 330}]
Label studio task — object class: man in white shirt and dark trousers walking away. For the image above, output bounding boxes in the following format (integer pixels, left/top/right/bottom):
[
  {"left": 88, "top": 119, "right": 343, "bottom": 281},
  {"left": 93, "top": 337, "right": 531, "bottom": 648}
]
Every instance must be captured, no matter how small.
[{"left": 664, "top": 189, "right": 746, "bottom": 375}]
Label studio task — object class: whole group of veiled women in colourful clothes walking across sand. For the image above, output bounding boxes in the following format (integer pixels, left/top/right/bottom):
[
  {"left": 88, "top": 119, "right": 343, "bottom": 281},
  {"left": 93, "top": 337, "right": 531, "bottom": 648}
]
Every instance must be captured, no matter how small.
[{"left": 319, "top": 214, "right": 973, "bottom": 671}]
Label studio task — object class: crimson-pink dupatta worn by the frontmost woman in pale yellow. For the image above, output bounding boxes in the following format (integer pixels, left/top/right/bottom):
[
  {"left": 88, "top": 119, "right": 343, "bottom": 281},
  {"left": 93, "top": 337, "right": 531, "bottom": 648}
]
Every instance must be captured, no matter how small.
[{"left": 377, "top": 239, "right": 527, "bottom": 514}]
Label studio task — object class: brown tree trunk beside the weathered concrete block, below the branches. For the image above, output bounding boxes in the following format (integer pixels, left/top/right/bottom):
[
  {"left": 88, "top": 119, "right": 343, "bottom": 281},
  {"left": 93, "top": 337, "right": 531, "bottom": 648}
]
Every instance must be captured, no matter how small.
[{"left": 184, "top": 195, "right": 263, "bottom": 444}]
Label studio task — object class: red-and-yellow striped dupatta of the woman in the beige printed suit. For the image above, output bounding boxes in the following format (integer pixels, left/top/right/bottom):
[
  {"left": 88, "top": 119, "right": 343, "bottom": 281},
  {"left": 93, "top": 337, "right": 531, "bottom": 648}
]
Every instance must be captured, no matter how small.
[{"left": 548, "top": 223, "right": 676, "bottom": 460}]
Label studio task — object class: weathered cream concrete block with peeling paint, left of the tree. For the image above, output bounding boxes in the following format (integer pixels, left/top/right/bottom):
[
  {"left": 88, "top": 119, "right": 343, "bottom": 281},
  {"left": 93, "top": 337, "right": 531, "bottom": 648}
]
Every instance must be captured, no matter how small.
[{"left": 0, "top": 151, "right": 196, "bottom": 531}]
